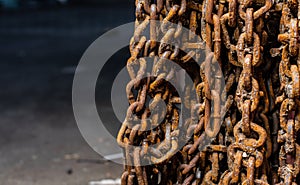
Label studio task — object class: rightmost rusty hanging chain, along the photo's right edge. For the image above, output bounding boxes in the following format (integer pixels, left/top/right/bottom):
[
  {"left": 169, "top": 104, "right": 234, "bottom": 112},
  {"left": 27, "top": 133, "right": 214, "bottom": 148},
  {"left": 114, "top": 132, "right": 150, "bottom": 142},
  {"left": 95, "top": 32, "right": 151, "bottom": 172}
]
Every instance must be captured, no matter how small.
[{"left": 276, "top": 1, "right": 299, "bottom": 185}]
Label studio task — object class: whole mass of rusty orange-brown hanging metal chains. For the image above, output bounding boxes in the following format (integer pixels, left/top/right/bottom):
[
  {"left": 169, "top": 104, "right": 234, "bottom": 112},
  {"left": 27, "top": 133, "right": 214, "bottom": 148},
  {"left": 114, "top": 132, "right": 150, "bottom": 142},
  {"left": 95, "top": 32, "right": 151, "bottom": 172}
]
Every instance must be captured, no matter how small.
[{"left": 117, "top": 0, "right": 300, "bottom": 185}]
